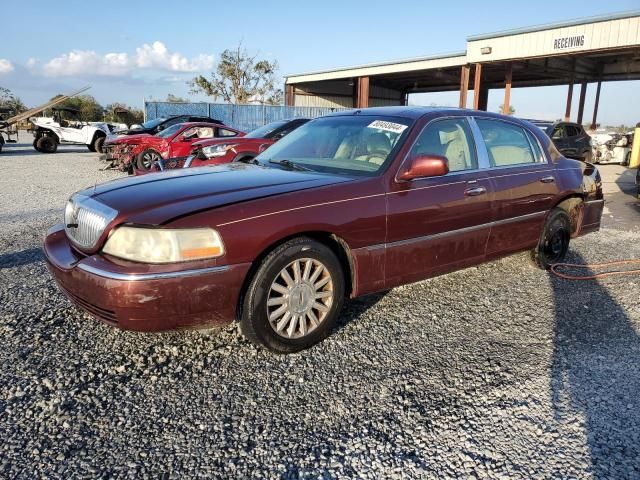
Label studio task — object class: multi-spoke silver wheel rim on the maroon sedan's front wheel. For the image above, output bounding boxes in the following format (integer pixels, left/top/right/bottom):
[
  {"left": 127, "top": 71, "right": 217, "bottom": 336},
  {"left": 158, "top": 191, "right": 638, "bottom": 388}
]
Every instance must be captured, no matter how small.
[{"left": 267, "top": 258, "right": 333, "bottom": 338}]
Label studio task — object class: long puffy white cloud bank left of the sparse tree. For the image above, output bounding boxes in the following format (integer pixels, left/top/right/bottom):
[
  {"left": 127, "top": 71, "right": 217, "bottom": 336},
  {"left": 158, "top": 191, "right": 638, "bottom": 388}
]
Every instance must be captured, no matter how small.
[{"left": 41, "top": 41, "right": 213, "bottom": 77}]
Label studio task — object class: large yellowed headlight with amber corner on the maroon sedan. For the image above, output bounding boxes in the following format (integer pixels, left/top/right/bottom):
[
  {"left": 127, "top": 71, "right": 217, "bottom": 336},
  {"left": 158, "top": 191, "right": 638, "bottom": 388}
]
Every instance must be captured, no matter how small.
[{"left": 102, "top": 226, "right": 224, "bottom": 263}]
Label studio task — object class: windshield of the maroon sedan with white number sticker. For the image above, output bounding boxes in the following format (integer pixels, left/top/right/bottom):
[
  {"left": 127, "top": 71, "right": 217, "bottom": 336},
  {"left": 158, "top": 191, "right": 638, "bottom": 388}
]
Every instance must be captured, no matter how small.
[{"left": 256, "top": 115, "right": 412, "bottom": 175}]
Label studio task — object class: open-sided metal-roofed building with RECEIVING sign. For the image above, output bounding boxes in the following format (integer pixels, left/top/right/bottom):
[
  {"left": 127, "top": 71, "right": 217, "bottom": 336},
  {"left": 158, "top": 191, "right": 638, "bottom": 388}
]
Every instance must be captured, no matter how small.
[{"left": 285, "top": 11, "right": 640, "bottom": 129}]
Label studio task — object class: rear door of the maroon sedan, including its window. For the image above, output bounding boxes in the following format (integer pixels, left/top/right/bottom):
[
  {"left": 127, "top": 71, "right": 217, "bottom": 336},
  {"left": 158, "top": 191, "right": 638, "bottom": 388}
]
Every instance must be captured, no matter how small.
[{"left": 474, "top": 118, "right": 558, "bottom": 258}]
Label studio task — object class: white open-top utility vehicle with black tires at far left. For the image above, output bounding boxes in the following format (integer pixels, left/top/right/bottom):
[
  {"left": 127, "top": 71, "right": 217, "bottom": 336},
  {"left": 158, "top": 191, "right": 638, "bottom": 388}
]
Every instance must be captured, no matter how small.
[{"left": 29, "top": 107, "right": 117, "bottom": 153}]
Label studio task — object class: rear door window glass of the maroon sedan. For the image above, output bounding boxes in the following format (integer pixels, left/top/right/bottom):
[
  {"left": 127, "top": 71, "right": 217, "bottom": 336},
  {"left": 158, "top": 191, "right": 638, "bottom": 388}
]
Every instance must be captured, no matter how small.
[{"left": 476, "top": 119, "right": 541, "bottom": 167}]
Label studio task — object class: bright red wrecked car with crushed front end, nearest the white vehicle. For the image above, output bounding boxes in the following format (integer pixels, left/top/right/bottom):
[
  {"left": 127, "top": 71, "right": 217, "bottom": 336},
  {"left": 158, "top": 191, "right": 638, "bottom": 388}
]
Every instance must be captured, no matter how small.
[{"left": 103, "top": 122, "right": 244, "bottom": 172}]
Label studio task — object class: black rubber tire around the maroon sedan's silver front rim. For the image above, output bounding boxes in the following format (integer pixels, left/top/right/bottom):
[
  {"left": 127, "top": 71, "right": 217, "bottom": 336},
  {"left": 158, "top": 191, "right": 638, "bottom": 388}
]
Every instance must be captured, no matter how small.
[{"left": 241, "top": 240, "right": 345, "bottom": 353}]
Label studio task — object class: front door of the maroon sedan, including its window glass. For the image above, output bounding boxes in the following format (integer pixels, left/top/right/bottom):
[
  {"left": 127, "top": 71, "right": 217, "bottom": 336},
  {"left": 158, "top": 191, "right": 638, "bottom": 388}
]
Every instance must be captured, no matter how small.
[{"left": 385, "top": 116, "right": 493, "bottom": 288}]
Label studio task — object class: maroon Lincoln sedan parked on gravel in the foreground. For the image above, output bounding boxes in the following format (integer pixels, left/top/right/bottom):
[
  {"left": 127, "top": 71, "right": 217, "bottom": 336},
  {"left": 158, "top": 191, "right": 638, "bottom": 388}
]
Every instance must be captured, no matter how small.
[{"left": 44, "top": 107, "right": 603, "bottom": 352}]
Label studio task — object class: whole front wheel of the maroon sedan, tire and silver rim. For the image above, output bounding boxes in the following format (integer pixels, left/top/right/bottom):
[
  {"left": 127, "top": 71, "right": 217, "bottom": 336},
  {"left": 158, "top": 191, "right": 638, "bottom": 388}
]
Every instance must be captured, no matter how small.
[{"left": 240, "top": 237, "right": 345, "bottom": 353}]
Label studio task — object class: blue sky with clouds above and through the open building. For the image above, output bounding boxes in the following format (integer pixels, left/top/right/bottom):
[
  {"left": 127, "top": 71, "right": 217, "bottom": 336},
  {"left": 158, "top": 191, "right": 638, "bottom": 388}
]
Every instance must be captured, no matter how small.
[{"left": 0, "top": 0, "right": 640, "bottom": 125}]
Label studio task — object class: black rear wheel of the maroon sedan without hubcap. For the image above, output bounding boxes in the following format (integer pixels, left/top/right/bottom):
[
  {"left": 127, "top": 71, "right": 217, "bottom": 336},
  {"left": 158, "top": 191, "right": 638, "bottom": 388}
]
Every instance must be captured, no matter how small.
[{"left": 531, "top": 208, "right": 571, "bottom": 270}]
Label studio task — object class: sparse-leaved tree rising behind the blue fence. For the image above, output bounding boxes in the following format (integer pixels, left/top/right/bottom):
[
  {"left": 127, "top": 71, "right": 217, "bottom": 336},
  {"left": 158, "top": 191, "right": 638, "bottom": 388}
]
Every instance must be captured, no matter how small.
[{"left": 189, "top": 44, "right": 282, "bottom": 105}]
